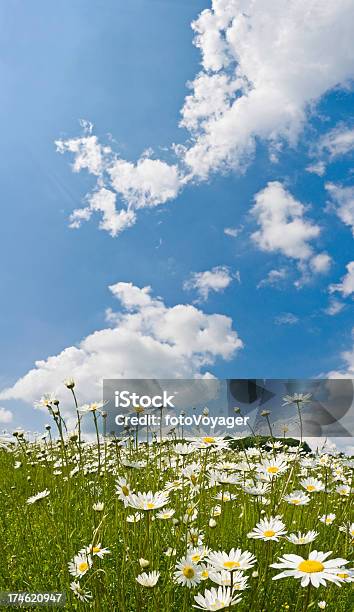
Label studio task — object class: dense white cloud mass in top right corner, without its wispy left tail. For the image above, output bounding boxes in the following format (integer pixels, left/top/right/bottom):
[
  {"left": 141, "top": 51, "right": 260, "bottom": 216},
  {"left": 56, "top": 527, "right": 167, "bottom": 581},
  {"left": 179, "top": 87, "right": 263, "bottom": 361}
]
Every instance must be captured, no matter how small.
[{"left": 182, "top": 0, "right": 354, "bottom": 178}]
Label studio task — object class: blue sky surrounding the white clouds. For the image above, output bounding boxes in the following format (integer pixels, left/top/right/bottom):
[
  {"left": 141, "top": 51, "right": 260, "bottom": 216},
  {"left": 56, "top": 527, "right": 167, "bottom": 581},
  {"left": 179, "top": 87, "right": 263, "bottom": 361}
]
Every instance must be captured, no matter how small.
[{"left": 0, "top": 0, "right": 354, "bottom": 427}]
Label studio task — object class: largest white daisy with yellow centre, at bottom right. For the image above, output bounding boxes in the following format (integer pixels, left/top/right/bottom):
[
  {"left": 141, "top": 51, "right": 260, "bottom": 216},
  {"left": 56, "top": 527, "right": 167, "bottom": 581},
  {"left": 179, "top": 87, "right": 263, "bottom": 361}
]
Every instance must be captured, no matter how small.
[{"left": 270, "top": 550, "right": 349, "bottom": 588}]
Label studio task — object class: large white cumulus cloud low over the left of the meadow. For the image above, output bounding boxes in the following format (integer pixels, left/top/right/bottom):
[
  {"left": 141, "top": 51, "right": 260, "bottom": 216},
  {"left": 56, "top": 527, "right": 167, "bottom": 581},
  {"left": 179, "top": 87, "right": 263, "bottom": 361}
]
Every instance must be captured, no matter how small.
[{"left": 0, "top": 283, "right": 243, "bottom": 410}]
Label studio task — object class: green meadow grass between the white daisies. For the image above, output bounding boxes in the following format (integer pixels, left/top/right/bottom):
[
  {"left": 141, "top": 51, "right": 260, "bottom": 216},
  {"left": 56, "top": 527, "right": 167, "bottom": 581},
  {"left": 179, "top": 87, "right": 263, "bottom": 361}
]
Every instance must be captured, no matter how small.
[{"left": 0, "top": 416, "right": 354, "bottom": 612}]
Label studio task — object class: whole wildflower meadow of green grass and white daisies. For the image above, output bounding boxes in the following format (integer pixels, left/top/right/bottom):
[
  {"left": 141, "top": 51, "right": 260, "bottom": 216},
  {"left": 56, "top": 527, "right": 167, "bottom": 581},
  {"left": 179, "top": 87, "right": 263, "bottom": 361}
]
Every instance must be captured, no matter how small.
[{"left": 0, "top": 386, "right": 354, "bottom": 612}]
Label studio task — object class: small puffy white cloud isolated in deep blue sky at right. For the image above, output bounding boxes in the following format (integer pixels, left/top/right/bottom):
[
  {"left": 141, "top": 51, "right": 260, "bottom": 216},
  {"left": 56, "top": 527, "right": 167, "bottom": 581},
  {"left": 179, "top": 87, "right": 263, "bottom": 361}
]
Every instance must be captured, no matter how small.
[{"left": 251, "top": 181, "right": 321, "bottom": 261}]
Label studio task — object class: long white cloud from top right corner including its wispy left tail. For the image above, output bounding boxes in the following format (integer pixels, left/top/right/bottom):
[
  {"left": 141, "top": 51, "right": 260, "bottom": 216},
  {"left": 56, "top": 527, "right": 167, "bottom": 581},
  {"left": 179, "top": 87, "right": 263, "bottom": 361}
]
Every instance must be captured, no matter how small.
[{"left": 57, "top": 0, "right": 354, "bottom": 236}]
